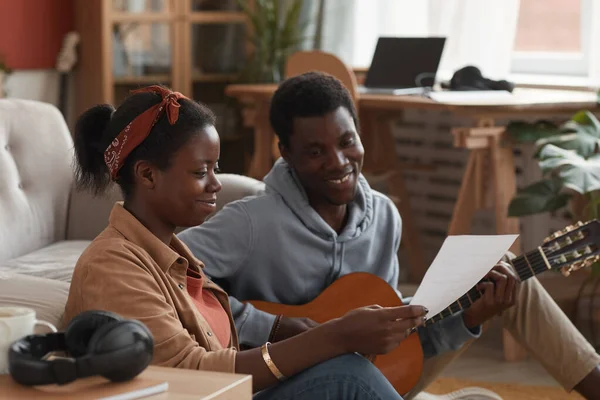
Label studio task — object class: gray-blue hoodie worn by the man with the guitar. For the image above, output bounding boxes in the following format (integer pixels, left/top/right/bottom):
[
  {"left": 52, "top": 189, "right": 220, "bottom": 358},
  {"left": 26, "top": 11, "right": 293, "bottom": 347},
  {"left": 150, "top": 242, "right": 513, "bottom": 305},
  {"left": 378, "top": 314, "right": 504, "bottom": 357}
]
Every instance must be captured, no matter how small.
[{"left": 179, "top": 159, "right": 479, "bottom": 356}]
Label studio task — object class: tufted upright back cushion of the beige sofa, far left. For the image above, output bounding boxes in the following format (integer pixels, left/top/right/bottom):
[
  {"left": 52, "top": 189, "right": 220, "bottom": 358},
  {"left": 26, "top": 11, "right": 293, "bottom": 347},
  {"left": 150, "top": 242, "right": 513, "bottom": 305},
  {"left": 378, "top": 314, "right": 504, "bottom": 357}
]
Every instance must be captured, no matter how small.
[{"left": 0, "top": 99, "right": 73, "bottom": 262}]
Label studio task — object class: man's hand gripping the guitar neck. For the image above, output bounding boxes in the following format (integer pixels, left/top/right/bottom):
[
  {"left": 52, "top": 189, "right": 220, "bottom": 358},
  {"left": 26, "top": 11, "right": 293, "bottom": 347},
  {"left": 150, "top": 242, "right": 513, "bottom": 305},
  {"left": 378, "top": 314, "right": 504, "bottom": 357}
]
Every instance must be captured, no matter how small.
[{"left": 463, "top": 261, "right": 519, "bottom": 329}]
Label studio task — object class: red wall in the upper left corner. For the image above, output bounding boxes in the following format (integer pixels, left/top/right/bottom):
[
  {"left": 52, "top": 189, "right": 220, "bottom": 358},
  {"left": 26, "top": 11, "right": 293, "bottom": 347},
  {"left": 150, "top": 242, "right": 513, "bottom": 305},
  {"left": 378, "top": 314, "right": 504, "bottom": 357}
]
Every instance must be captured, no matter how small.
[{"left": 0, "top": 0, "right": 74, "bottom": 69}]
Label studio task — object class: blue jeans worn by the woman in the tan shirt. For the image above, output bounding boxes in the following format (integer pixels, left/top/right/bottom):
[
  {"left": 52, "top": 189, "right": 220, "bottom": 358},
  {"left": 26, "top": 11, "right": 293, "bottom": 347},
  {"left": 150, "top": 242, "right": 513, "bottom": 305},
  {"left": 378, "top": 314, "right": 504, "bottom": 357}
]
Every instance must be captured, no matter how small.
[{"left": 253, "top": 354, "right": 402, "bottom": 400}]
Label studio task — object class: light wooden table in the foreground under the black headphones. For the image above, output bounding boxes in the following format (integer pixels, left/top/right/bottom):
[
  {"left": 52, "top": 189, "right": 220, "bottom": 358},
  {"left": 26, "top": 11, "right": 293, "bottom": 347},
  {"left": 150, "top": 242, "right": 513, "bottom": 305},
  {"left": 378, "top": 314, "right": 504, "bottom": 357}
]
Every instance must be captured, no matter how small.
[{"left": 0, "top": 366, "right": 252, "bottom": 400}]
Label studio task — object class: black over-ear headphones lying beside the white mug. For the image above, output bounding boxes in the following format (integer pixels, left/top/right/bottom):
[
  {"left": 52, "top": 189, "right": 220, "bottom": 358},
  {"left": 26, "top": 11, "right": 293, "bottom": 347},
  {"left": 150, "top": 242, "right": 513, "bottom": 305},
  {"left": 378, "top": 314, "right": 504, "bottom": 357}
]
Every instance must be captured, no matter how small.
[{"left": 8, "top": 311, "right": 154, "bottom": 386}]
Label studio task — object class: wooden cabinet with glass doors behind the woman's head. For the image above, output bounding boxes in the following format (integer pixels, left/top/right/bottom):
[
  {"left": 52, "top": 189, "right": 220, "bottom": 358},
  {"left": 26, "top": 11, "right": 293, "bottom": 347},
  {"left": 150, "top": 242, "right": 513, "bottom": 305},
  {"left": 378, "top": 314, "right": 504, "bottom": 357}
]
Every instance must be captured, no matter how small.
[{"left": 74, "top": 0, "right": 256, "bottom": 130}]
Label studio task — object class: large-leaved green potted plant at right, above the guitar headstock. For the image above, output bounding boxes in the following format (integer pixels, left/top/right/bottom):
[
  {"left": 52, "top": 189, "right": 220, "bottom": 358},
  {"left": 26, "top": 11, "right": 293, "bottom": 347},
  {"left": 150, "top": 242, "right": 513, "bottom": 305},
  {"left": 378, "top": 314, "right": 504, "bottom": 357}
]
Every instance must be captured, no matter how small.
[{"left": 508, "top": 111, "right": 600, "bottom": 348}]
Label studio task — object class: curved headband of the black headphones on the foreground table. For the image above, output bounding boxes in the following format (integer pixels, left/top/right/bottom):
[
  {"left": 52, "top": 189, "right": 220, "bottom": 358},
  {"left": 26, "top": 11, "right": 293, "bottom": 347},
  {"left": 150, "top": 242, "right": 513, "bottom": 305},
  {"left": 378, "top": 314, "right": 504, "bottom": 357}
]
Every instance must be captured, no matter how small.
[{"left": 65, "top": 310, "right": 123, "bottom": 357}]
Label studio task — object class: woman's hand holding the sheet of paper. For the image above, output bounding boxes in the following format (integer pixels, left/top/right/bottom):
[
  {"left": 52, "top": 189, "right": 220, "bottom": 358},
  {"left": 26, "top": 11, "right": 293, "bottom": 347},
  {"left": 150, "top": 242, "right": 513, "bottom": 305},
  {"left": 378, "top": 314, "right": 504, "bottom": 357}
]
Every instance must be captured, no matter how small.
[{"left": 329, "top": 305, "right": 427, "bottom": 354}]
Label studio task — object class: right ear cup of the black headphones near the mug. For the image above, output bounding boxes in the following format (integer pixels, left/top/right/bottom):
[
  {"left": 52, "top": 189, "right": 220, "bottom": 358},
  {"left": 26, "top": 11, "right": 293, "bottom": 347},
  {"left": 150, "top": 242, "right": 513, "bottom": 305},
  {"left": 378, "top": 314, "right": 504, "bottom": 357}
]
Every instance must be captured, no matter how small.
[{"left": 88, "top": 320, "right": 154, "bottom": 382}]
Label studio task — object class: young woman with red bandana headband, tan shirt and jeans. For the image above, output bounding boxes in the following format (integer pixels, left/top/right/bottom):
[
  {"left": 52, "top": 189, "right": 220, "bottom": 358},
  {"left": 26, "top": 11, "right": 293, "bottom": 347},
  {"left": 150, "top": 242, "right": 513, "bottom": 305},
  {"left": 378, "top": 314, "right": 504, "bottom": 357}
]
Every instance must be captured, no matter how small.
[{"left": 64, "top": 86, "right": 426, "bottom": 400}]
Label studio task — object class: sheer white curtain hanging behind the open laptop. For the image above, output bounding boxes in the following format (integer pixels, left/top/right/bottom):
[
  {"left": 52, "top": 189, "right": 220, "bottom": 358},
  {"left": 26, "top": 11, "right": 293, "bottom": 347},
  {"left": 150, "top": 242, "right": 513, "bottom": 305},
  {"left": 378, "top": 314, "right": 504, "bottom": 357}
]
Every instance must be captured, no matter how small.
[{"left": 323, "top": 0, "right": 519, "bottom": 79}]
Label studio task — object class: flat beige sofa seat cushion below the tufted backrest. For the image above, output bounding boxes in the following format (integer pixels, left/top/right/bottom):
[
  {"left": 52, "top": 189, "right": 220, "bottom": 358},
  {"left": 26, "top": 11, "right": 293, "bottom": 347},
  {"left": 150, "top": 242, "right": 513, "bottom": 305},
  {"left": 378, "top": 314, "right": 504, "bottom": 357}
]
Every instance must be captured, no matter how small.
[{"left": 0, "top": 240, "right": 90, "bottom": 282}]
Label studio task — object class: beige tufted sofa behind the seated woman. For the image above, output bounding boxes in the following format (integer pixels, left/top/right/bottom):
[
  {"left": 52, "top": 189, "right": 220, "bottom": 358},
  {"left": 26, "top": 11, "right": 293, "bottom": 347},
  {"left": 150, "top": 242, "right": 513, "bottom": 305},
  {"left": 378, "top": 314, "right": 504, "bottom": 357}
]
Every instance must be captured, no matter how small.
[{"left": 0, "top": 99, "right": 264, "bottom": 325}]
